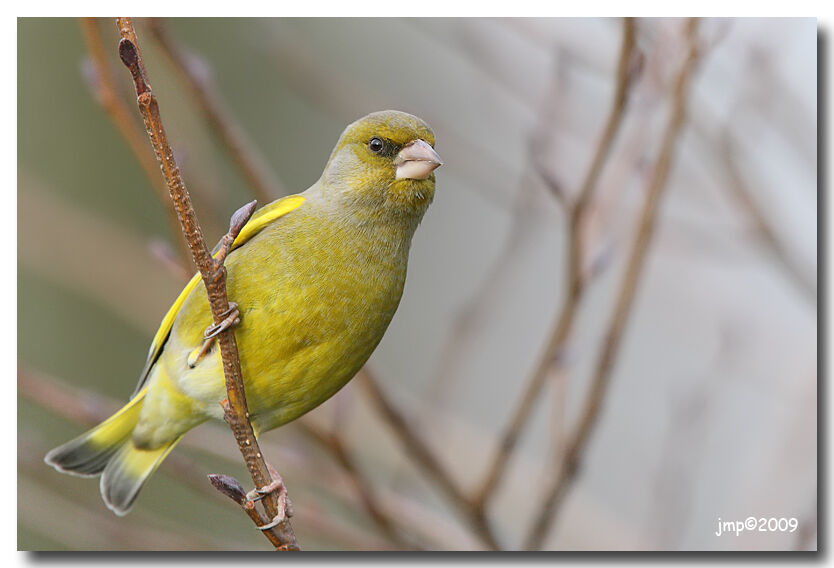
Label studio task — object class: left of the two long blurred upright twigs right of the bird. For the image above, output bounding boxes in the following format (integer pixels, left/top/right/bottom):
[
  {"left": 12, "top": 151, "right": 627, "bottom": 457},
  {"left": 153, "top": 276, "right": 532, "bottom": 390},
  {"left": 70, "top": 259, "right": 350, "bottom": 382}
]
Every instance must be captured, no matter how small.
[{"left": 473, "top": 18, "right": 635, "bottom": 508}]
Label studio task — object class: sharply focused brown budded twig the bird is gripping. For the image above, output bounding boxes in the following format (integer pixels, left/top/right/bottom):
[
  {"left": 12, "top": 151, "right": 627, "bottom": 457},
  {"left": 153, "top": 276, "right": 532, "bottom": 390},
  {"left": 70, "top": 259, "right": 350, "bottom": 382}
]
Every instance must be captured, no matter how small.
[{"left": 116, "top": 18, "right": 298, "bottom": 550}]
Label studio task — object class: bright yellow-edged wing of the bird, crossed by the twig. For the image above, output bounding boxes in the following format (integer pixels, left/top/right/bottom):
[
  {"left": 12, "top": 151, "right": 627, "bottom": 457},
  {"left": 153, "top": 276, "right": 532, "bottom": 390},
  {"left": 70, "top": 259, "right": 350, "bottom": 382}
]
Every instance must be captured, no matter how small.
[{"left": 131, "top": 195, "right": 305, "bottom": 398}]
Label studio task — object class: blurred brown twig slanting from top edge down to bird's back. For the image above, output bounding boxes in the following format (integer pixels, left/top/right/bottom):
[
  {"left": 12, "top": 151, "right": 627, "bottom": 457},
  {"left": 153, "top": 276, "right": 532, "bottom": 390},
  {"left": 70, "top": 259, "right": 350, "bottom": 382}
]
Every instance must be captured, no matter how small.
[{"left": 150, "top": 18, "right": 285, "bottom": 203}]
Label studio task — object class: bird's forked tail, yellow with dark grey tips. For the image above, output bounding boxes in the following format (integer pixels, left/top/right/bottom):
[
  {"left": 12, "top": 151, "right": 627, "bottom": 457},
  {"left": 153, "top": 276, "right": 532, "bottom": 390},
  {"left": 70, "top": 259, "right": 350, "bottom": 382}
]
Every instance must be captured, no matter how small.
[{"left": 44, "top": 390, "right": 180, "bottom": 516}]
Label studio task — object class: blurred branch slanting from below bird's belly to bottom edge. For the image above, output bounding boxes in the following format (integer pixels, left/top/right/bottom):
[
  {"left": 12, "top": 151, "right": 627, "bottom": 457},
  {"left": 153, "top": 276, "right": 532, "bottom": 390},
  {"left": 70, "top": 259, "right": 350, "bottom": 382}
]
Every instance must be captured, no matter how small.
[{"left": 358, "top": 366, "right": 500, "bottom": 550}]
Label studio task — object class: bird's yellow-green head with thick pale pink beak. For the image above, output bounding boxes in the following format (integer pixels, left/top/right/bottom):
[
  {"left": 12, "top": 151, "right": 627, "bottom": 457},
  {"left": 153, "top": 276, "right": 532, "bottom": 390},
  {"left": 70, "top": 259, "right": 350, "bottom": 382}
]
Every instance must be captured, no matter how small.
[{"left": 322, "top": 110, "right": 443, "bottom": 220}]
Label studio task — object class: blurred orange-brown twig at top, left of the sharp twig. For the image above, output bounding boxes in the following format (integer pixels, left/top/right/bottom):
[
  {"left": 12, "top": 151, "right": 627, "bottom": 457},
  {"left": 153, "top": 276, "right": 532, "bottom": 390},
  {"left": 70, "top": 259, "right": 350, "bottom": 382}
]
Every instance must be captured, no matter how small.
[{"left": 80, "top": 18, "right": 191, "bottom": 264}]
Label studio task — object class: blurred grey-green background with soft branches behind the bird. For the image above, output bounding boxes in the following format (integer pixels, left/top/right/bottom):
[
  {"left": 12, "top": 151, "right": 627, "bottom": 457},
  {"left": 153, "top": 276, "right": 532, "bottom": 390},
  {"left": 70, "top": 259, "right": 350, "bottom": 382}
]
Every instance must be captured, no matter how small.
[{"left": 17, "top": 19, "right": 817, "bottom": 550}]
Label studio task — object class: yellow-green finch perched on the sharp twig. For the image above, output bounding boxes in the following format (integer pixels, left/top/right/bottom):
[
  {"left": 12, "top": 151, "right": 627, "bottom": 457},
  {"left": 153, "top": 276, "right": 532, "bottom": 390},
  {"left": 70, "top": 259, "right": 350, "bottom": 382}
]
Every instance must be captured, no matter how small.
[{"left": 44, "top": 110, "right": 443, "bottom": 516}]
